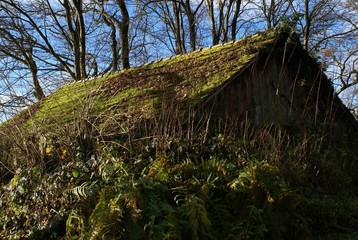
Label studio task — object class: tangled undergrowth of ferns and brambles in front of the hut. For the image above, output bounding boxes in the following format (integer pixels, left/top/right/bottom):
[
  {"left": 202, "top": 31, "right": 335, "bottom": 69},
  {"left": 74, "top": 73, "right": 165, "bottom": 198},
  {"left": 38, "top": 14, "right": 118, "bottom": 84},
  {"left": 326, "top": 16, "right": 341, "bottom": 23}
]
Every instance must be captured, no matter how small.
[{"left": 0, "top": 119, "right": 358, "bottom": 239}]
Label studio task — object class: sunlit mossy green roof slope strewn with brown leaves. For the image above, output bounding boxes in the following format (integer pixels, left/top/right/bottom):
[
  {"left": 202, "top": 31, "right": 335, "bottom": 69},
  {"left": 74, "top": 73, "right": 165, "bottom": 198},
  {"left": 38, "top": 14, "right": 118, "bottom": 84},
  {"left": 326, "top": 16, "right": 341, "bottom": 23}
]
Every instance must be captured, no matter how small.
[{"left": 0, "top": 32, "right": 277, "bottom": 135}]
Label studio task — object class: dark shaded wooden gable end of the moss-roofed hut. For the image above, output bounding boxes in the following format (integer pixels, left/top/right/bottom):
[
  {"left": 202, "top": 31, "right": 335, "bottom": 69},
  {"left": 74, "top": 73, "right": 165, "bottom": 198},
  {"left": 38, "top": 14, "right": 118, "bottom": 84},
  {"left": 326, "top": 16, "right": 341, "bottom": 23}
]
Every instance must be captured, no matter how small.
[{"left": 194, "top": 33, "right": 357, "bottom": 137}]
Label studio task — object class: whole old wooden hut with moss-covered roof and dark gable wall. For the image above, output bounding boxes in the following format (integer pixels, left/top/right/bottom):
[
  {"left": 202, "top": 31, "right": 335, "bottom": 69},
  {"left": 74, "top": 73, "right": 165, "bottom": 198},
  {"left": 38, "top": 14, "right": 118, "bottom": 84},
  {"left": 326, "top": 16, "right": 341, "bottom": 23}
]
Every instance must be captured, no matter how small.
[{"left": 0, "top": 31, "right": 358, "bottom": 178}]
